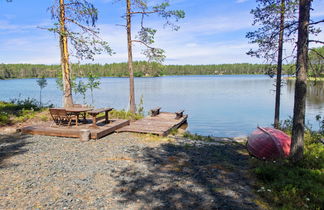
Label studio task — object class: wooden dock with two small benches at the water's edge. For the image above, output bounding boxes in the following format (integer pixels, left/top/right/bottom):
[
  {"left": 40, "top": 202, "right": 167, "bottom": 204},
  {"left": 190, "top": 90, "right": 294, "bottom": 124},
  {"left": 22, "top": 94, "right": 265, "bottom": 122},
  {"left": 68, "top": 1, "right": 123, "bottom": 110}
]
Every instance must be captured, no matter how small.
[{"left": 116, "top": 112, "right": 188, "bottom": 136}]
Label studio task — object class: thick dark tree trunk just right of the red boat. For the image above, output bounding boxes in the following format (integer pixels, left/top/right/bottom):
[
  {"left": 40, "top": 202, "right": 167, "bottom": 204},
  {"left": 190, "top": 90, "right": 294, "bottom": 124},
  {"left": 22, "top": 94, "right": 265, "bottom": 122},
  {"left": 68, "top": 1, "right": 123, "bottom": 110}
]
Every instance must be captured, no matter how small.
[{"left": 291, "top": 0, "right": 311, "bottom": 162}]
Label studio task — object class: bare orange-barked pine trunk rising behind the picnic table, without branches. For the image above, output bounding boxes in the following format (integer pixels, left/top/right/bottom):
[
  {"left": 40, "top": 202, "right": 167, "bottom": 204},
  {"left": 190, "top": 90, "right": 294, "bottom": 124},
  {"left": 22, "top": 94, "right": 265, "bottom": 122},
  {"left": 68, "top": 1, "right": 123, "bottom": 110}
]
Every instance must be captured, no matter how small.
[{"left": 60, "top": 0, "right": 73, "bottom": 107}]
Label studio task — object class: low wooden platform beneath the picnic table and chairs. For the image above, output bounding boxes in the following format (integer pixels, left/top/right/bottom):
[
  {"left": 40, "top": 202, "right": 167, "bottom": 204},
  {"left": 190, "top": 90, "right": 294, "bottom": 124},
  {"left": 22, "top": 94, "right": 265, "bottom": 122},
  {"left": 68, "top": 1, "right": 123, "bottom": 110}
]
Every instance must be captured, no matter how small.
[{"left": 21, "top": 119, "right": 129, "bottom": 139}]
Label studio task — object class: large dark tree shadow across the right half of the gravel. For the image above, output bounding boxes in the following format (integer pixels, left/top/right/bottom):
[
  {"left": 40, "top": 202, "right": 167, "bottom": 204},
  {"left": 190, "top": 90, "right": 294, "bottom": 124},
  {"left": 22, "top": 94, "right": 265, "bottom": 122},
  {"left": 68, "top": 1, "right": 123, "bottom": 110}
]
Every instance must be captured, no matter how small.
[{"left": 113, "top": 142, "right": 258, "bottom": 209}]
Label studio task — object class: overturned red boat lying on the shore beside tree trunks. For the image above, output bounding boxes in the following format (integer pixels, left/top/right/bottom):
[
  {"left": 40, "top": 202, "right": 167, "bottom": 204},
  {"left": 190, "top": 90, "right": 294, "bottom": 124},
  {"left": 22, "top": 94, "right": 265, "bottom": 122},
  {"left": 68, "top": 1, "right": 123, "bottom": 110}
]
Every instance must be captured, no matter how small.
[{"left": 247, "top": 127, "right": 291, "bottom": 160}]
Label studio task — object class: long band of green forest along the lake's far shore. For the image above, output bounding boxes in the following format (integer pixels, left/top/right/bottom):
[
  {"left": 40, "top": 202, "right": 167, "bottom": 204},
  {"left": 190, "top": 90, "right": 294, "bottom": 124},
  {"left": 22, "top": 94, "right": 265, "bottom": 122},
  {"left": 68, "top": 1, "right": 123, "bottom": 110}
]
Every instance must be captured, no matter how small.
[{"left": 0, "top": 61, "right": 293, "bottom": 79}]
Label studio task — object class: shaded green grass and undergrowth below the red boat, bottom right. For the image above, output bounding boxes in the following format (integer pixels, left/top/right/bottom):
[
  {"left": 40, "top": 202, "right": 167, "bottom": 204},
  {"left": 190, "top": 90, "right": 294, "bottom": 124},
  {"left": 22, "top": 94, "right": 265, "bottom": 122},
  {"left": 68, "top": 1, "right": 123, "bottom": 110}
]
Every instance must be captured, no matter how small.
[{"left": 251, "top": 132, "right": 324, "bottom": 209}]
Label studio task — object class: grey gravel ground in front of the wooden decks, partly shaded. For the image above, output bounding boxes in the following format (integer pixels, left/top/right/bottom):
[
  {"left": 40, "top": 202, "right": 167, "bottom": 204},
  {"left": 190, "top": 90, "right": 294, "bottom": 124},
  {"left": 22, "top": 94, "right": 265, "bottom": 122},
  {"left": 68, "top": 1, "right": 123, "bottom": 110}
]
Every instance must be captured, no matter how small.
[{"left": 0, "top": 133, "right": 260, "bottom": 209}]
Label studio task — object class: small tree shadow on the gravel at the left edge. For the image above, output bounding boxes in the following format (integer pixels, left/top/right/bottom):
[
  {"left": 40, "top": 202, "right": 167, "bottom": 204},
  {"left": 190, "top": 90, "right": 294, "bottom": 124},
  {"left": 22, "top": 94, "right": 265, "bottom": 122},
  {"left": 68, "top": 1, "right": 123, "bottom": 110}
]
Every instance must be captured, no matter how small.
[{"left": 0, "top": 133, "right": 28, "bottom": 169}]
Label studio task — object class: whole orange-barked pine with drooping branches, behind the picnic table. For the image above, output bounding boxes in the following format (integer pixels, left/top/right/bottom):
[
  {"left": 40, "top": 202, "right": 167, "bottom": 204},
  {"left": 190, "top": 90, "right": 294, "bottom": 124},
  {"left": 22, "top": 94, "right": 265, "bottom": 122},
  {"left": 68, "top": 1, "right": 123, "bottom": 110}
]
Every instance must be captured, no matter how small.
[{"left": 48, "top": 0, "right": 112, "bottom": 107}]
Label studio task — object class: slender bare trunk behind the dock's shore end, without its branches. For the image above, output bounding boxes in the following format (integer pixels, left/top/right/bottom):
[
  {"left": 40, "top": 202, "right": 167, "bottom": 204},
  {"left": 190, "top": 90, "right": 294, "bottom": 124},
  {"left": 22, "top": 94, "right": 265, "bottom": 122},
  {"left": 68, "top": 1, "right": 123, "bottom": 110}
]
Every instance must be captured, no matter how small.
[{"left": 126, "top": 0, "right": 136, "bottom": 113}]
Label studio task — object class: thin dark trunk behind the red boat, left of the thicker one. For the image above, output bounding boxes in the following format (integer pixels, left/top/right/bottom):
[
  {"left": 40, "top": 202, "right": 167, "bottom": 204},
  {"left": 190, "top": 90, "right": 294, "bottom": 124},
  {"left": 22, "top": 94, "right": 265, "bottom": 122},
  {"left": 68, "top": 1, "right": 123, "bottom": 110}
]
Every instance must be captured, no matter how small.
[{"left": 274, "top": 0, "right": 286, "bottom": 128}]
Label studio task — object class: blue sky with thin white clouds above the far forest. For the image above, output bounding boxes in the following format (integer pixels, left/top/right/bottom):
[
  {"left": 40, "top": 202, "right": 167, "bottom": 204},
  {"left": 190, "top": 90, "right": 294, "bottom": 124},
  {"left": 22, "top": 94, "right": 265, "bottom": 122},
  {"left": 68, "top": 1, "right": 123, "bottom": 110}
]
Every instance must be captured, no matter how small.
[{"left": 0, "top": 0, "right": 324, "bottom": 65}]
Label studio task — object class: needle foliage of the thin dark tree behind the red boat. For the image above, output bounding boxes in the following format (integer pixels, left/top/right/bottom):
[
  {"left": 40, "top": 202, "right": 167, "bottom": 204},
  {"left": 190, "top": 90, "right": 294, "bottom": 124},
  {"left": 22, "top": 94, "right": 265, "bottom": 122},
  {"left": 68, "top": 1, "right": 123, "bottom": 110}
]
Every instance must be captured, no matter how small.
[{"left": 246, "top": 0, "right": 298, "bottom": 64}]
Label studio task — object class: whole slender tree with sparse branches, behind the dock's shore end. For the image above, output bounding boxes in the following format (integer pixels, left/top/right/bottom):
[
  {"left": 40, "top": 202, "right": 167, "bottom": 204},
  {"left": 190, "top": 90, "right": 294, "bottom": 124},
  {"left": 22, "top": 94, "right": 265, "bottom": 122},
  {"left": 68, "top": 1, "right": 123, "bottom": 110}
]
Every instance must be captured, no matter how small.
[{"left": 119, "top": 0, "right": 185, "bottom": 113}]
